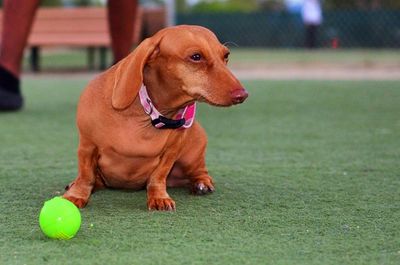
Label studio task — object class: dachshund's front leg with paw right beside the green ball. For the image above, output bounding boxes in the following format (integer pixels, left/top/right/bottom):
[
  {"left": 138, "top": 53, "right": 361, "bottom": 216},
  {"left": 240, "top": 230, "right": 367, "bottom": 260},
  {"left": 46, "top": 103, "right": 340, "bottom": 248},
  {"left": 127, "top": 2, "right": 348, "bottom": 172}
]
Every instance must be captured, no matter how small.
[{"left": 64, "top": 137, "right": 98, "bottom": 208}]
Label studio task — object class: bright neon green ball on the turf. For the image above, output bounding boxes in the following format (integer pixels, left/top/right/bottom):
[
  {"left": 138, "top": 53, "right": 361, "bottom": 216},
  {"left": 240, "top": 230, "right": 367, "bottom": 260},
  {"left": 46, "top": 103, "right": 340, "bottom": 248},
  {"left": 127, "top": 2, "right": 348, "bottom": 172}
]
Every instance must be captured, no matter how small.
[{"left": 39, "top": 197, "right": 81, "bottom": 239}]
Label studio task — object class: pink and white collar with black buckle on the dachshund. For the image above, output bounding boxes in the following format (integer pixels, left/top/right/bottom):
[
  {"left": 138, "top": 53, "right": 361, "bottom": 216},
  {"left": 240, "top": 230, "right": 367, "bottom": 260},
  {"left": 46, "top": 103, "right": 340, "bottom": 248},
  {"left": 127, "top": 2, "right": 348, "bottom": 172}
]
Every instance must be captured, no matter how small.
[{"left": 139, "top": 84, "right": 196, "bottom": 129}]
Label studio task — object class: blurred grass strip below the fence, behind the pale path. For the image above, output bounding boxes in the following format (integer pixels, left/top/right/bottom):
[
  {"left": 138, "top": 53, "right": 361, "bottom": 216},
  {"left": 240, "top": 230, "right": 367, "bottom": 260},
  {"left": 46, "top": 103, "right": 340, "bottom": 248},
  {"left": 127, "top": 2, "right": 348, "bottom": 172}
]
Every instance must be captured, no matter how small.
[{"left": 24, "top": 47, "right": 400, "bottom": 71}]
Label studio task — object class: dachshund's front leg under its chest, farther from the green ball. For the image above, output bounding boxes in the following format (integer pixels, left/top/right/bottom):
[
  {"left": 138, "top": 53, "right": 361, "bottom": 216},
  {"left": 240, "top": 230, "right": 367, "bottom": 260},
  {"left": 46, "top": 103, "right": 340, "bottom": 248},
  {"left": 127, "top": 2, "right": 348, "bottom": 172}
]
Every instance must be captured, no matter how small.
[{"left": 147, "top": 152, "right": 176, "bottom": 211}]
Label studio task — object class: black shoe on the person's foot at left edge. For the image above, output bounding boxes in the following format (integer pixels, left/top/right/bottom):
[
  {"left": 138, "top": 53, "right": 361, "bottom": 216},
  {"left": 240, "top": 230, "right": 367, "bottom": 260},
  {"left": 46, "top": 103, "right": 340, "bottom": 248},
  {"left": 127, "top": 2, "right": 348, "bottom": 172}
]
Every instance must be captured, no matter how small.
[{"left": 0, "top": 66, "right": 24, "bottom": 112}]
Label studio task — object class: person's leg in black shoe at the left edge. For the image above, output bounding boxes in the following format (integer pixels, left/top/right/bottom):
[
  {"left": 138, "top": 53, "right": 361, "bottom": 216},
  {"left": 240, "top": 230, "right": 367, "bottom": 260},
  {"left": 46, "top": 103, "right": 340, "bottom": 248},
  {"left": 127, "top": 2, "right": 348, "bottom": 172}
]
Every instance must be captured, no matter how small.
[{"left": 0, "top": 0, "right": 40, "bottom": 111}]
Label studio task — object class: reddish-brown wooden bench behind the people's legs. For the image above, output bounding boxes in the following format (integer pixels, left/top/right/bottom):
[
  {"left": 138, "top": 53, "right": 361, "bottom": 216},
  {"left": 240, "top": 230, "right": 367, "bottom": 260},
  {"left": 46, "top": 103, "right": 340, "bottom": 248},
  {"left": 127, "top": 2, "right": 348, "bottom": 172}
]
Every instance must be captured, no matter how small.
[{"left": 0, "top": 7, "right": 147, "bottom": 71}]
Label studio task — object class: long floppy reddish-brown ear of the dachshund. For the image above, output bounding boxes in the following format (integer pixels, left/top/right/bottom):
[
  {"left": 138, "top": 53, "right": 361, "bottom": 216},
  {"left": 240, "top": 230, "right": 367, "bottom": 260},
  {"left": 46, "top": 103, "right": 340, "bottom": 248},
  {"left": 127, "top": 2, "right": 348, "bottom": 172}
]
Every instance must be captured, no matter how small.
[{"left": 111, "top": 37, "right": 161, "bottom": 110}]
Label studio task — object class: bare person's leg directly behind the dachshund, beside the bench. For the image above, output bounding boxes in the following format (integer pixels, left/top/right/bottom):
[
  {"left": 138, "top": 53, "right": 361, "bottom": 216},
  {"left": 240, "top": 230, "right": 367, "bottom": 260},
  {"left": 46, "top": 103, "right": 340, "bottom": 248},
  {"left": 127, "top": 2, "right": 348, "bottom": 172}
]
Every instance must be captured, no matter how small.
[{"left": 108, "top": 0, "right": 138, "bottom": 63}]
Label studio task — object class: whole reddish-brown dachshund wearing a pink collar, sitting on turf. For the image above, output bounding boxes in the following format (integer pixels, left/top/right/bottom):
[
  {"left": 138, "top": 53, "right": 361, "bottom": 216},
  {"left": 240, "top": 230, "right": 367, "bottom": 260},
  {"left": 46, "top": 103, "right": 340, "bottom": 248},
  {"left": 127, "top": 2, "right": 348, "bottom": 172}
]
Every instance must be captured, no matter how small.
[{"left": 64, "top": 26, "right": 248, "bottom": 211}]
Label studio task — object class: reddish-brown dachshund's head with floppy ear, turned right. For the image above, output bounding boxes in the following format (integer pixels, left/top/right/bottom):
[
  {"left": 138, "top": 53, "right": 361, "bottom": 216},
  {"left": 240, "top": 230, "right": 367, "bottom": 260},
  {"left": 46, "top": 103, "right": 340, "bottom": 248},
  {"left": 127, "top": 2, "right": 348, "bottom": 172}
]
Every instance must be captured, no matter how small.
[{"left": 112, "top": 26, "right": 248, "bottom": 109}]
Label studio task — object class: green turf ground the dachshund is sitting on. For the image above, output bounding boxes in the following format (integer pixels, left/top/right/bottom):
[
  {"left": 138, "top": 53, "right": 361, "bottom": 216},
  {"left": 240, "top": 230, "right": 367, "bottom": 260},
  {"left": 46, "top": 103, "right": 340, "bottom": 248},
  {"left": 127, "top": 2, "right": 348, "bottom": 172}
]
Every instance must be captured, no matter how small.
[{"left": 0, "top": 78, "right": 400, "bottom": 265}]
